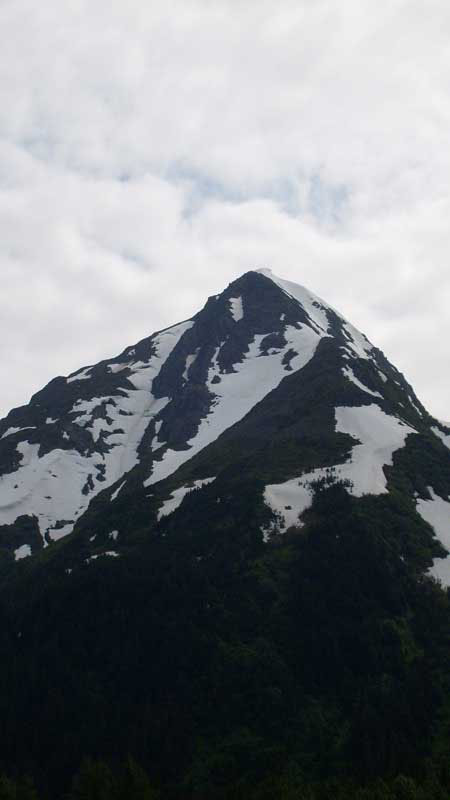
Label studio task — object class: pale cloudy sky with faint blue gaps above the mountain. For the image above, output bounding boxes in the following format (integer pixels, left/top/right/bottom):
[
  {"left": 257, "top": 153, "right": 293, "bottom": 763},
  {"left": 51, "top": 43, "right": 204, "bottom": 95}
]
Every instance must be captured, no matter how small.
[{"left": 0, "top": 0, "right": 450, "bottom": 419}]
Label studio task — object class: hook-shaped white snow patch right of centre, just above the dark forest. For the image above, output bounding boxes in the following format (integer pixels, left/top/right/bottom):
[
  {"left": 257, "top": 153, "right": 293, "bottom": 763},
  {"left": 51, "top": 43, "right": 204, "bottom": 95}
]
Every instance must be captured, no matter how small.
[{"left": 264, "top": 403, "right": 417, "bottom": 530}]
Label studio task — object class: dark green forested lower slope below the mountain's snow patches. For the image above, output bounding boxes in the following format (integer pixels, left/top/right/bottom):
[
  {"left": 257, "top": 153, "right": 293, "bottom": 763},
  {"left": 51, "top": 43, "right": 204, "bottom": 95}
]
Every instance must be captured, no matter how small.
[{"left": 0, "top": 485, "right": 450, "bottom": 800}]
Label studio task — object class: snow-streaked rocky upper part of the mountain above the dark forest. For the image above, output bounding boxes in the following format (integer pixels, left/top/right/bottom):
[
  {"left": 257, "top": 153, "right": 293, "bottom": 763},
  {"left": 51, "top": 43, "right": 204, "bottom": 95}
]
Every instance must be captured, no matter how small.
[{"left": 0, "top": 269, "right": 450, "bottom": 582}]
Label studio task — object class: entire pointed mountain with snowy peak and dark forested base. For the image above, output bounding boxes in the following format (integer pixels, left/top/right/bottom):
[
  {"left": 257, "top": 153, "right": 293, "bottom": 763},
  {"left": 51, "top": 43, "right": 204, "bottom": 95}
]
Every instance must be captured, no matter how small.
[{"left": 0, "top": 270, "right": 450, "bottom": 800}]
